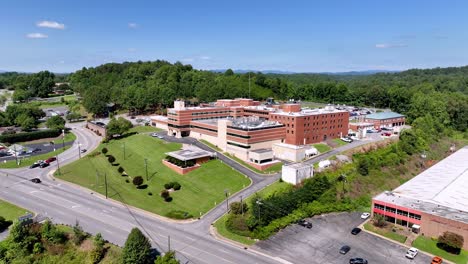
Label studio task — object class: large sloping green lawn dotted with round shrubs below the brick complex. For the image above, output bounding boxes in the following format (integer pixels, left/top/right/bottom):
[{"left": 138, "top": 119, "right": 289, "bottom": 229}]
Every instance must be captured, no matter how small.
[{"left": 58, "top": 135, "right": 250, "bottom": 217}]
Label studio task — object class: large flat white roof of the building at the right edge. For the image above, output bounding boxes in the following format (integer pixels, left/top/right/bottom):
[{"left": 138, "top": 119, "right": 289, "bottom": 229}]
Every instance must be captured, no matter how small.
[{"left": 375, "top": 146, "right": 468, "bottom": 223}]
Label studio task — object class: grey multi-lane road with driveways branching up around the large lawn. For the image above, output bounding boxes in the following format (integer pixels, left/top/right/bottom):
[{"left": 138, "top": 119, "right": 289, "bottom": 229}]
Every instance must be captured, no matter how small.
[{"left": 0, "top": 123, "right": 388, "bottom": 264}]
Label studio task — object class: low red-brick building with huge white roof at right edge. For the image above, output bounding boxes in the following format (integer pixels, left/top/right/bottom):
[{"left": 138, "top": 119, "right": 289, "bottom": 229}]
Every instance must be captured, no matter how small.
[{"left": 372, "top": 146, "right": 468, "bottom": 249}]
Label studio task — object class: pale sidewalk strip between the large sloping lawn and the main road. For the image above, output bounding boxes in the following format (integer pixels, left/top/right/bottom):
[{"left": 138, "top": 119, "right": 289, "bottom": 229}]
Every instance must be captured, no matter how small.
[{"left": 47, "top": 170, "right": 198, "bottom": 224}]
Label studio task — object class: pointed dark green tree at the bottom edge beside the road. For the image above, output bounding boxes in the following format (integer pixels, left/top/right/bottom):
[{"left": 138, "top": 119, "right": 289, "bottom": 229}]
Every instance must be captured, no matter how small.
[{"left": 122, "top": 227, "right": 152, "bottom": 264}]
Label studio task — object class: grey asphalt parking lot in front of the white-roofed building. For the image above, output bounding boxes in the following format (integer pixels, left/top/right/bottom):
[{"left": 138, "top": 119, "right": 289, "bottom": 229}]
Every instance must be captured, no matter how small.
[{"left": 254, "top": 213, "right": 431, "bottom": 264}]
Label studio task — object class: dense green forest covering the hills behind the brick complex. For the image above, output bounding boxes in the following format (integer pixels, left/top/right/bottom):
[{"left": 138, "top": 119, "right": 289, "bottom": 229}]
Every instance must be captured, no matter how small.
[{"left": 0, "top": 60, "right": 468, "bottom": 131}]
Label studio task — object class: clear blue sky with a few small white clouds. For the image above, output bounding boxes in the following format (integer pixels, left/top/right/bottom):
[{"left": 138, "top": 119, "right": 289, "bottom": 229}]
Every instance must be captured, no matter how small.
[{"left": 0, "top": 0, "right": 468, "bottom": 72}]
